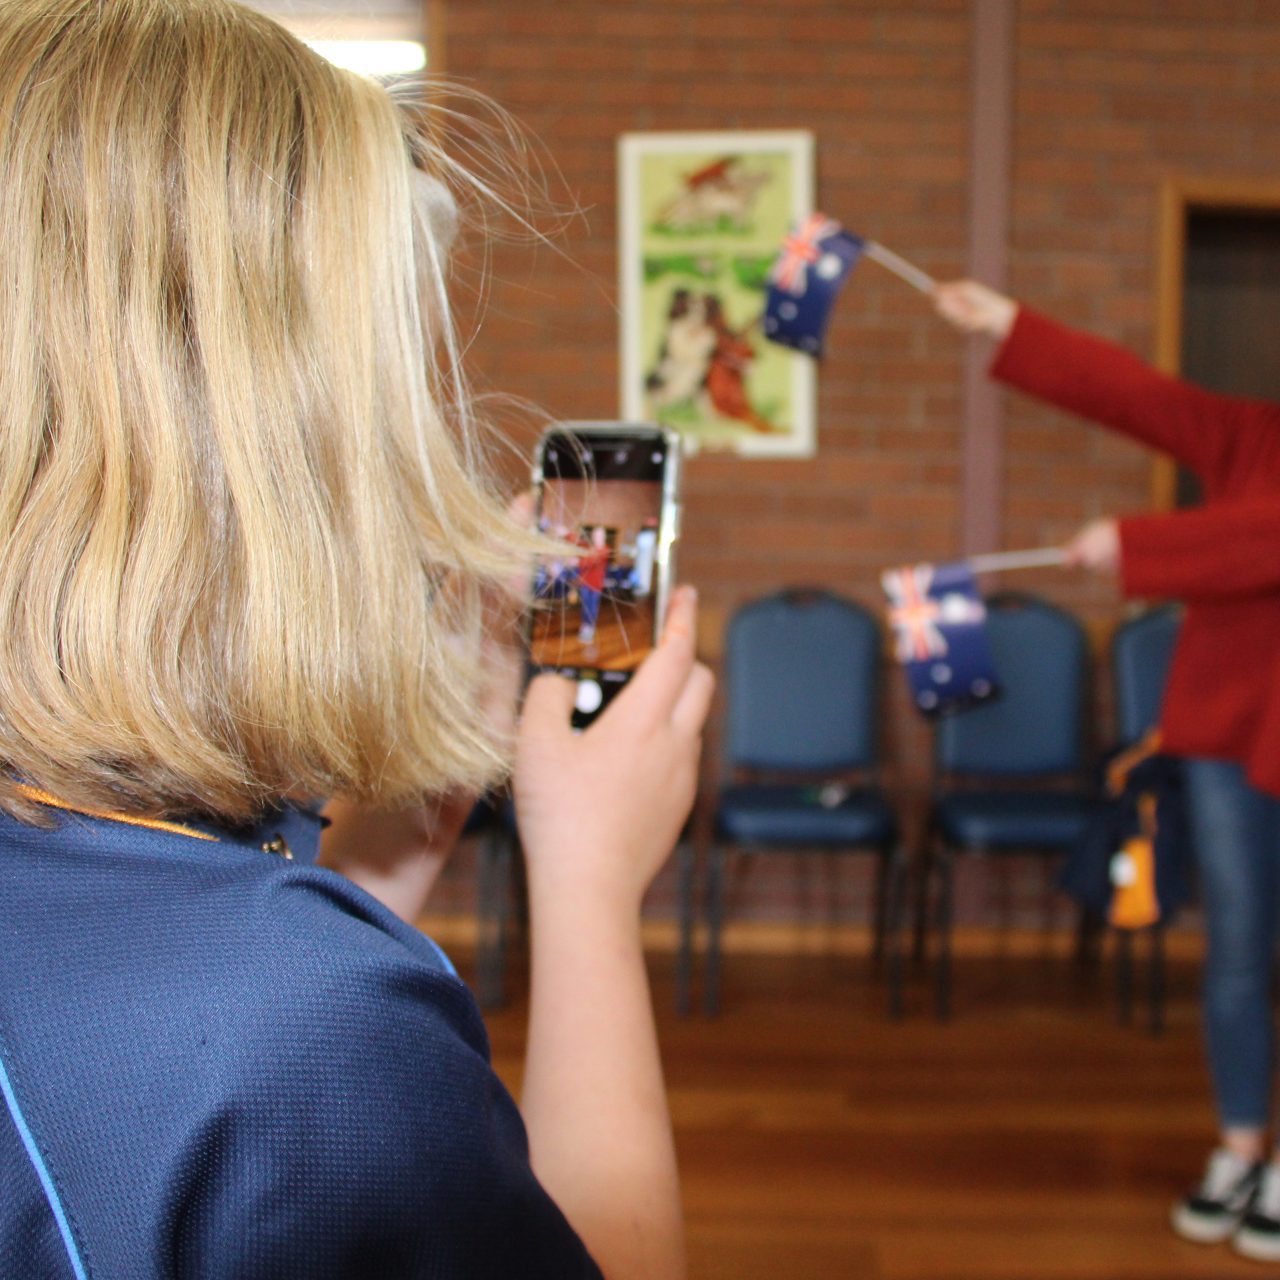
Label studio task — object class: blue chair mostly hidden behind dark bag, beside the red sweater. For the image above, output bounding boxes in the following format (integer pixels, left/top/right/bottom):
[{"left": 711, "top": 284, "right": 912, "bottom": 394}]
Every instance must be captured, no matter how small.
[{"left": 1111, "top": 604, "right": 1183, "bottom": 1034}]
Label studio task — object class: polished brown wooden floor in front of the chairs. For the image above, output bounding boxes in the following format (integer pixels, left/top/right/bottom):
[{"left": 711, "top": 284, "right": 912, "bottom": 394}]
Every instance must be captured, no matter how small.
[{"left": 476, "top": 956, "right": 1280, "bottom": 1280}]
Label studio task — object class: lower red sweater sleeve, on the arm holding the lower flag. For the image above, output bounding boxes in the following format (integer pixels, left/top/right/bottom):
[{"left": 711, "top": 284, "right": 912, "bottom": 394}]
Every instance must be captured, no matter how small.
[{"left": 1120, "top": 498, "right": 1280, "bottom": 600}]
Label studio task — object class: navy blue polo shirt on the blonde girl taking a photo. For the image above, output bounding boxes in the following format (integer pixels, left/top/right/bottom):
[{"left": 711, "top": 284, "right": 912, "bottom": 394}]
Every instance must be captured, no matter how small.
[{"left": 0, "top": 793, "right": 599, "bottom": 1280}]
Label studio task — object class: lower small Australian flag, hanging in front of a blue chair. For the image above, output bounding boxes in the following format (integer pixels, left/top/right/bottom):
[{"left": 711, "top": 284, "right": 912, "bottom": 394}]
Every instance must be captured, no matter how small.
[{"left": 881, "top": 561, "right": 997, "bottom": 716}]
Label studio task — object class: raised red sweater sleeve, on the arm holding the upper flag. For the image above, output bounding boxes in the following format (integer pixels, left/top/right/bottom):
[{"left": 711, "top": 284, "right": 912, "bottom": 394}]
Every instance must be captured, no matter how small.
[{"left": 991, "top": 307, "right": 1280, "bottom": 484}]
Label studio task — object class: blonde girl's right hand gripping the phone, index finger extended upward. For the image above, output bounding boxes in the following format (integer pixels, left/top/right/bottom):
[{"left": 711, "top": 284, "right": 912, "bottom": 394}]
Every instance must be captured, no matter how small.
[{"left": 515, "top": 588, "right": 714, "bottom": 916}]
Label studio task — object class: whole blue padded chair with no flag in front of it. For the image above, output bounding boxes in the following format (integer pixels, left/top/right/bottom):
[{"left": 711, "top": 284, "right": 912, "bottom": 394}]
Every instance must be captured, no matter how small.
[{"left": 704, "top": 590, "right": 904, "bottom": 1015}]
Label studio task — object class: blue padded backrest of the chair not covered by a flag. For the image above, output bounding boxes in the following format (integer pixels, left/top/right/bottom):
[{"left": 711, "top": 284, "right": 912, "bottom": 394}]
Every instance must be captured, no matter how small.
[{"left": 724, "top": 590, "right": 881, "bottom": 772}]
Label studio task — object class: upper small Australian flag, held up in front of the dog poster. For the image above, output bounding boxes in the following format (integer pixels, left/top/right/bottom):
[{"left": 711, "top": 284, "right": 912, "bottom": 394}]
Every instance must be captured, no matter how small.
[{"left": 764, "top": 214, "right": 863, "bottom": 356}]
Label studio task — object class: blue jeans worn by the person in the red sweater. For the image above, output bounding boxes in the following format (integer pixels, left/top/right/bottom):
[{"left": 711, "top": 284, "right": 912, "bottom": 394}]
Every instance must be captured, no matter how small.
[{"left": 1187, "top": 760, "right": 1280, "bottom": 1129}]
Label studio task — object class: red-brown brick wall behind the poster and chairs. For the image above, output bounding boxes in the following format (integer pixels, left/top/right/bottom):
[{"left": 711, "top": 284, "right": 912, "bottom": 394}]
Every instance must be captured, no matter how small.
[{"left": 432, "top": 0, "right": 1280, "bottom": 931}]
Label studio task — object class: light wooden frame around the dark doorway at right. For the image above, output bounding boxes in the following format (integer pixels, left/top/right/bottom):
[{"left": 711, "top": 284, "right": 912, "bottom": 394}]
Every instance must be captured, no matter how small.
[{"left": 1151, "top": 177, "right": 1280, "bottom": 511}]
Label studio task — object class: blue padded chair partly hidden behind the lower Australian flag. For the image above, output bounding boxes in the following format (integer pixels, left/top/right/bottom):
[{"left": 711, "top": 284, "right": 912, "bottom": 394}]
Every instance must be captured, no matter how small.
[{"left": 916, "top": 594, "right": 1096, "bottom": 1019}]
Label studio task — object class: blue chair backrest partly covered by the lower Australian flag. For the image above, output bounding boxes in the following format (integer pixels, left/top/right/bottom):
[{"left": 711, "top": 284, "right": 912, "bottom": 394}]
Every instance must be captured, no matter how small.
[{"left": 934, "top": 594, "right": 1088, "bottom": 777}]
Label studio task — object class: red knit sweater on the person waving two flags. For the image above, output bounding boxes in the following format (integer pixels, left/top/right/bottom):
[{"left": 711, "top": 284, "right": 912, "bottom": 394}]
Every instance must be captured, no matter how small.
[{"left": 992, "top": 307, "right": 1280, "bottom": 796}]
